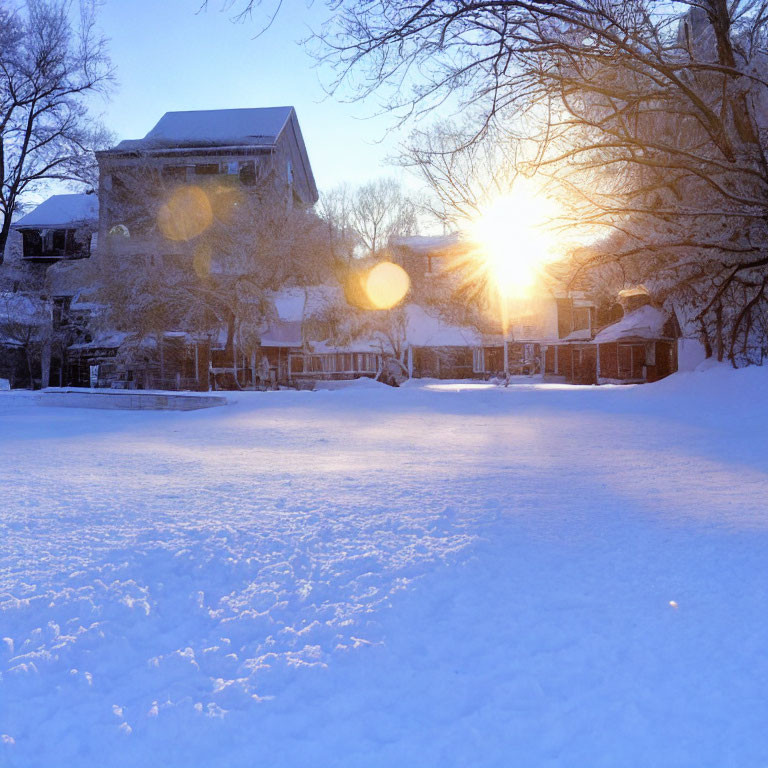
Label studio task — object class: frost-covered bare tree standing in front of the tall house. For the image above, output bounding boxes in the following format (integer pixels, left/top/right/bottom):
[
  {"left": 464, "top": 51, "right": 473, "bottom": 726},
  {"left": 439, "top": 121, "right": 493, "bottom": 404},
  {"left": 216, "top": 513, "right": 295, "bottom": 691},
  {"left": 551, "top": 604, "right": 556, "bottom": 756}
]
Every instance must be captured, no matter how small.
[{"left": 94, "top": 159, "right": 332, "bottom": 378}]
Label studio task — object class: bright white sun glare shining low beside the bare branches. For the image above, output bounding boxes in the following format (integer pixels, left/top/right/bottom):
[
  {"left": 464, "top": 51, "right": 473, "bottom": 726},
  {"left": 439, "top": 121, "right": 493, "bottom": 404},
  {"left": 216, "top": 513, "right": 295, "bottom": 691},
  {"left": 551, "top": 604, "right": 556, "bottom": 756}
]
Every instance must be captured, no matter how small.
[{"left": 472, "top": 183, "right": 557, "bottom": 298}]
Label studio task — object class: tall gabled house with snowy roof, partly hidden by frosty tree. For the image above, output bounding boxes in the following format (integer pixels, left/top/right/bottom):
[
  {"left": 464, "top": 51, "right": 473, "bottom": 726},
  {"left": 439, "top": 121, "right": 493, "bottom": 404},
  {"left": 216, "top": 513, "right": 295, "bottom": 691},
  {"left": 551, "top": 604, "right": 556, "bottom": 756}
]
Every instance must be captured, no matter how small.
[{"left": 85, "top": 107, "right": 318, "bottom": 389}]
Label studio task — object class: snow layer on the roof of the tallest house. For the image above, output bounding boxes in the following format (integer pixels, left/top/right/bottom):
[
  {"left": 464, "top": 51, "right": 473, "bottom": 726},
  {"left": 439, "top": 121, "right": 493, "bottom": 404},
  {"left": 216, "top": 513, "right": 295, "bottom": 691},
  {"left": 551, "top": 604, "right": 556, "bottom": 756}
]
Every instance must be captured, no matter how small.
[{"left": 115, "top": 107, "right": 293, "bottom": 150}]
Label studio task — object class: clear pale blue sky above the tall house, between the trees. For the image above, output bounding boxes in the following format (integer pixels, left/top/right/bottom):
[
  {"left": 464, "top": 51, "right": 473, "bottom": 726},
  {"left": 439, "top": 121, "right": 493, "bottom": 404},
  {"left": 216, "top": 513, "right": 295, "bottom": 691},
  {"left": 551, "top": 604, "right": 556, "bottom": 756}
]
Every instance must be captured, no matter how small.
[{"left": 88, "top": 0, "right": 412, "bottom": 195}]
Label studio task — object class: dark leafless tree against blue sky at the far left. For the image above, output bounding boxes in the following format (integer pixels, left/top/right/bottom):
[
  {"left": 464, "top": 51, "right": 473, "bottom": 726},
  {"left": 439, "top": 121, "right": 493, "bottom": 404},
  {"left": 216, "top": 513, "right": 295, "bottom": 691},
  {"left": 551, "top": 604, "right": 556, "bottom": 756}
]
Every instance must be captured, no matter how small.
[{"left": 0, "top": 0, "right": 112, "bottom": 263}]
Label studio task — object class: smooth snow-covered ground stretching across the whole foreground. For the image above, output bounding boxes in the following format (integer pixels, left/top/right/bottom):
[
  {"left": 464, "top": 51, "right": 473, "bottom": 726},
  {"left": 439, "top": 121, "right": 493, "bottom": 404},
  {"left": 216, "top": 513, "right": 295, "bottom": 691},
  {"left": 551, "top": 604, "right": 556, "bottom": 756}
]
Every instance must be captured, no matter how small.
[{"left": 0, "top": 368, "right": 768, "bottom": 768}]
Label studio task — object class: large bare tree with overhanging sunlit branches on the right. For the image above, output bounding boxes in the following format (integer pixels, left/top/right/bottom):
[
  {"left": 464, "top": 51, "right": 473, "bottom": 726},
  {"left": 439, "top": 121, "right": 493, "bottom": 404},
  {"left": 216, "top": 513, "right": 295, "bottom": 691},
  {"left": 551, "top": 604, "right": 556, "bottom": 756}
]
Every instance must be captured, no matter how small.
[{"left": 308, "top": 0, "right": 768, "bottom": 364}]
